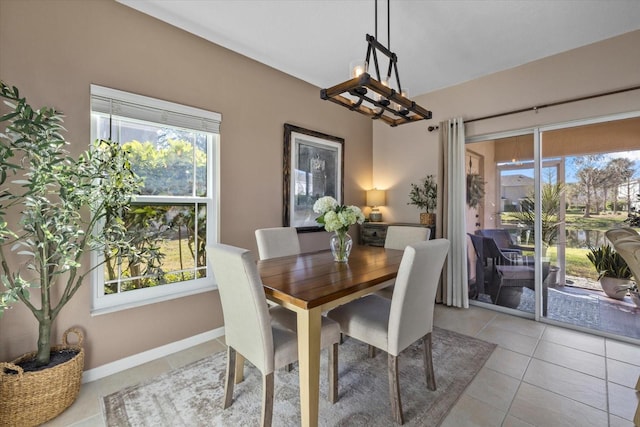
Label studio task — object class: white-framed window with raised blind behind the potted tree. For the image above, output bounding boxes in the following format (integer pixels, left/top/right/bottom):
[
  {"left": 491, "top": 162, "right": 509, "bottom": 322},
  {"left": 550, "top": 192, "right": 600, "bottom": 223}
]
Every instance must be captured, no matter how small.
[{"left": 91, "top": 85, "right": 221, "bottom": 313}]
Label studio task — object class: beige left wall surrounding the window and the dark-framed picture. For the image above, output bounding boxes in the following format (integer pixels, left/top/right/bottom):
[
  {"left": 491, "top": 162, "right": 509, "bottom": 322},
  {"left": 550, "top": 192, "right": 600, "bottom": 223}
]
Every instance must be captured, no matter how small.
[{"left": 0, "top": 0, "right": 372, "bottom": 369}]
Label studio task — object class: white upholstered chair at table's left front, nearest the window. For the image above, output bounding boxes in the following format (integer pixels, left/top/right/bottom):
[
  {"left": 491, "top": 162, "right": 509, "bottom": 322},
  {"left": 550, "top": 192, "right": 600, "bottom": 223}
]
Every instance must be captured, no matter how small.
[{"left": 207, "top": 244, "right": 340, "bottom": 426}]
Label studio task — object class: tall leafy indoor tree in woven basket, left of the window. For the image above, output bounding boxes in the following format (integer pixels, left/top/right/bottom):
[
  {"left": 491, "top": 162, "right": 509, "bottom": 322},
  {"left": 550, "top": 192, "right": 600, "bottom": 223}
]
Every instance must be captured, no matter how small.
[{"left": 0, "top": 81, "right": 146, "bottom": 426}]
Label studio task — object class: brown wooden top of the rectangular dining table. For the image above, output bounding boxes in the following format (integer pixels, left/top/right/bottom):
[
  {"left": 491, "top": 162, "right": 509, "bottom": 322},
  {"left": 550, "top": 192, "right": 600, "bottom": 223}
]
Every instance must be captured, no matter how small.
[{"left": 258, "top": 245, "right": 403, "bottom": 310}]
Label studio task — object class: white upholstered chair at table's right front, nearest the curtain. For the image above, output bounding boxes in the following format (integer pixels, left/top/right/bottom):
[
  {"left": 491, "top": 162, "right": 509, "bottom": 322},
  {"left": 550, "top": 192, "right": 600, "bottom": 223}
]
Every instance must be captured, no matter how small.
[{"left": 327, "top": 239, "right": 449, "bottom": 424}]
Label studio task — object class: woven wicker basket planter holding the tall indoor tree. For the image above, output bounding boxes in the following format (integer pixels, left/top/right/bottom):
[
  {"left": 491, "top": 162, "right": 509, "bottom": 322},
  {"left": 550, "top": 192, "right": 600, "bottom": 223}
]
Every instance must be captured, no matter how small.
[{"left": 0, "top": 328, "right": 84, "bottom": 427}]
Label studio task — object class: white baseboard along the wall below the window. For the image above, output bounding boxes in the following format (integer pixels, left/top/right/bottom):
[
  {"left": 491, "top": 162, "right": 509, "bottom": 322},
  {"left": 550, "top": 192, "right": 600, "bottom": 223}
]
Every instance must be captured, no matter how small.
[{"left": 82, "top": 327, "right": 224, "bottom": 383}]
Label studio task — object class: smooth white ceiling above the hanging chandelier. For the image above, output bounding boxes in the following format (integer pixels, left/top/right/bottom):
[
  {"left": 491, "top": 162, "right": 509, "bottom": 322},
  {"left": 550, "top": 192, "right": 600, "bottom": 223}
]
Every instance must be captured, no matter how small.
[{"left": 117, "top": 0, "right": 640, "bottom": 96}]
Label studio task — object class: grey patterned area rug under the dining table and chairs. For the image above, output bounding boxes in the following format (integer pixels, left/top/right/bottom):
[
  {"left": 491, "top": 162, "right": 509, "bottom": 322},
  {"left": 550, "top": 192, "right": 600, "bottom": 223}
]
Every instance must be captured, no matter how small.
[{"left": 103, "top": 328, "right": 496, "bottom": 427}]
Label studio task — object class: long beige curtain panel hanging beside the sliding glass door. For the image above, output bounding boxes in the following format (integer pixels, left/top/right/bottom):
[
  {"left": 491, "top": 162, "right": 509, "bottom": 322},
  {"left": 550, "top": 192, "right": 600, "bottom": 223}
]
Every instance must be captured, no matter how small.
[{"left": 436, "top": 118, "right": 469, "bottom": 308}]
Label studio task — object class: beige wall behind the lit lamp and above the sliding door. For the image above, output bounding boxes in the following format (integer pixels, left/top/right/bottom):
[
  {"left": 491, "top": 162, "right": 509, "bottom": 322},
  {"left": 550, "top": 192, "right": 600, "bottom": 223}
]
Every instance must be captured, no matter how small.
[{"left": 373, "top": 31, "right": 640, "bottom": 222}]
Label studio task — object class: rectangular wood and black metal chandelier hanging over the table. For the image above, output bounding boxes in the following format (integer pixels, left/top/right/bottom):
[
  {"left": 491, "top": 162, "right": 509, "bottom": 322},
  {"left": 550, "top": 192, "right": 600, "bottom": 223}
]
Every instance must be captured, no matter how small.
[{"left": 320, "top": 0, "right": 431, "bottom": 127}]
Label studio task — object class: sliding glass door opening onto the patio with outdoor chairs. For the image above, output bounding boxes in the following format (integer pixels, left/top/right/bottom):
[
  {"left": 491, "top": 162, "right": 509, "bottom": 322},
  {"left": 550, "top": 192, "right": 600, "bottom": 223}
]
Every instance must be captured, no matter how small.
[{"left": 467, "top": 114, "right": 640, "bottom": 339}]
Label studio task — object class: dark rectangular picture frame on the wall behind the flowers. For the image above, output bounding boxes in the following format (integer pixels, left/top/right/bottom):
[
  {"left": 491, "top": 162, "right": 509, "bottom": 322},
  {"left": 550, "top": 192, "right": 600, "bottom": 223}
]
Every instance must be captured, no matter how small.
[{"left": 282, "top": 123, "right": 344, "bottom": 233}]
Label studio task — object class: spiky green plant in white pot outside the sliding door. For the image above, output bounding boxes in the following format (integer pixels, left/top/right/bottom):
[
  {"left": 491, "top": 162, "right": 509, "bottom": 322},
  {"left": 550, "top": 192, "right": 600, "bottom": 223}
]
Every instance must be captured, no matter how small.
[{"left": 587, "top": 244, "right": 632, "bottom": 300}]
